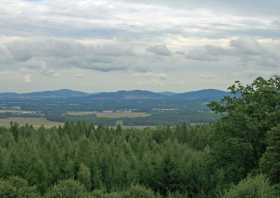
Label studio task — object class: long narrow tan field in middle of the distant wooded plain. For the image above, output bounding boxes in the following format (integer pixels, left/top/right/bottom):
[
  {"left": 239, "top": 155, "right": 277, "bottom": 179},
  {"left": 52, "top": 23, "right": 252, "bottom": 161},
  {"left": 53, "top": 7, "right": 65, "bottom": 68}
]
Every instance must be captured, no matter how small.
[{"left": 65, "top": 111, "right": 150, "bottom": 119}]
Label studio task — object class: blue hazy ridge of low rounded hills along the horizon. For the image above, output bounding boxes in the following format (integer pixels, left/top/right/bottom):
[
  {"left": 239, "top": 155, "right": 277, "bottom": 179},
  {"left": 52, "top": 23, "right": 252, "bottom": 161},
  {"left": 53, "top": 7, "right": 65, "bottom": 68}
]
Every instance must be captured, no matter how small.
[{"left": 0, "top": 89, "right": 229, "bottom": 101}]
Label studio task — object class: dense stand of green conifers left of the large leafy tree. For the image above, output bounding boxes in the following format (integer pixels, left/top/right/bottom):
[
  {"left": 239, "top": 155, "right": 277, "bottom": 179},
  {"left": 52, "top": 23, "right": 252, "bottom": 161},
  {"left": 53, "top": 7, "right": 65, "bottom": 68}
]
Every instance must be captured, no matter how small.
[{"left": 0, "top": 123, "right": 215, "bottom": 198}]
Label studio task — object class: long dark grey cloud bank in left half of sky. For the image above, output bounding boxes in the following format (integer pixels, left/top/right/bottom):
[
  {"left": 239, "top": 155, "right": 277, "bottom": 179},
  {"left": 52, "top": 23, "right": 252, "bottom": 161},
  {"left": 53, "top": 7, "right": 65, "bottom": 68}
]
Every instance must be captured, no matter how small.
[{"left": 0, "top": 39, "right": 139, "bottom": 74}]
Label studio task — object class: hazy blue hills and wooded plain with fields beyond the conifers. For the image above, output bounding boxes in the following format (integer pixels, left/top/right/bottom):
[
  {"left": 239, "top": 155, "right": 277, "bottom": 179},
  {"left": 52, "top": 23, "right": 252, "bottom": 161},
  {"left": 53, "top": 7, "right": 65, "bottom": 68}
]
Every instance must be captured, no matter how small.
[{"left": 0, "top": 89, "right": 229, "bottom": 126}]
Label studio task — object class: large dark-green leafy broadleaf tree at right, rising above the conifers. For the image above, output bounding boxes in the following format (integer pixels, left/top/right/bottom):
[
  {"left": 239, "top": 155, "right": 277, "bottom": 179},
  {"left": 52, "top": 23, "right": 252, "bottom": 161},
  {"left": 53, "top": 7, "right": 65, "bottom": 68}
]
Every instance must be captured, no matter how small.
[{"left": 209, "top": 76, "right": 280, "bottom": 183}]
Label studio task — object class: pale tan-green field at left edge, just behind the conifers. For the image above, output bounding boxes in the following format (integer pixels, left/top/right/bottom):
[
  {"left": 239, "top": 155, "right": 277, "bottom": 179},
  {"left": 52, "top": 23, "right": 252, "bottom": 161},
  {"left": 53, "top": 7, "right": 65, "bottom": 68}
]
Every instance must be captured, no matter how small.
[{"left": 0, "top": 117, "right": 63, "bottom": 128}]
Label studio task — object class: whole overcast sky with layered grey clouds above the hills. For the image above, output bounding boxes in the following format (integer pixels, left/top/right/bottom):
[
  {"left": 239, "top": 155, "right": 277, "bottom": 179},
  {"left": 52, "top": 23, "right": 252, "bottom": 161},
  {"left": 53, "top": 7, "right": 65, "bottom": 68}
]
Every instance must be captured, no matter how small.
[{"left": 0, "top": 0, "right": 280, "bottom": 92}]
